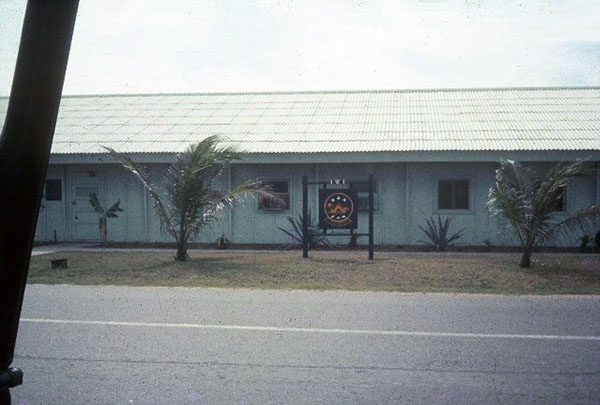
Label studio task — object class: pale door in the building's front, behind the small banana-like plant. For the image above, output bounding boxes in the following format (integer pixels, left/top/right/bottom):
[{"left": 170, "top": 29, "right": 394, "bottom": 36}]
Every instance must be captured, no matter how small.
[{"left": 71, "top": 171, "right": 102, "bottom": 241}]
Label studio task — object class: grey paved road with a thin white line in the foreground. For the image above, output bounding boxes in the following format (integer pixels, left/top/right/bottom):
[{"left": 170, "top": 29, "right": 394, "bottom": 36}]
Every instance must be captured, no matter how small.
[{"left": 13, "top": 285, "right": 600, "bottom": 404}]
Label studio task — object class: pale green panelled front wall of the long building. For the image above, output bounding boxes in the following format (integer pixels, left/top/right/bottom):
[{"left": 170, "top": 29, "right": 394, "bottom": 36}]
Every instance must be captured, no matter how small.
[{"left": 36, "top": 158, "right": 597, "bottom": 246}]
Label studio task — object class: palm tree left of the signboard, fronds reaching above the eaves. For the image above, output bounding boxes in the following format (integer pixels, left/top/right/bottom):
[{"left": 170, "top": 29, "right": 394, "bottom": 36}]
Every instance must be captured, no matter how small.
[{"left": 105, "top": 135, "right": 272, "bottom": 261}]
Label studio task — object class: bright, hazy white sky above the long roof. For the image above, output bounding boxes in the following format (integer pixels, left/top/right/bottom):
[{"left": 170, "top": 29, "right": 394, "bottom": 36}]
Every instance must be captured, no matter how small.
[{"left": 0, "top": 0, "right": 600, "bottom": 95}]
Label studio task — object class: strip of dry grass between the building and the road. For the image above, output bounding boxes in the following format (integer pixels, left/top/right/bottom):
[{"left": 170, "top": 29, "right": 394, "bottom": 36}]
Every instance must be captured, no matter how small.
[{"left": 28, "top": 251, "right": 600, "bottom": 294}]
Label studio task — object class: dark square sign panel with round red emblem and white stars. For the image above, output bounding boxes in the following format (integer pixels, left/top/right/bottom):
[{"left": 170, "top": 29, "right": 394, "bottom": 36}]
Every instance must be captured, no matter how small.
[{"left": 319, "top": 190, "right": 357, "bottom": 229}]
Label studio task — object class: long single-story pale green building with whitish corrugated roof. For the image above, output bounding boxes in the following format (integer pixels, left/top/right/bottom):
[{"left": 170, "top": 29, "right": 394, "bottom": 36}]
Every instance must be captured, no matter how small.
[{"left": 1, "top": 87, "right": 600, "bottom": 246}]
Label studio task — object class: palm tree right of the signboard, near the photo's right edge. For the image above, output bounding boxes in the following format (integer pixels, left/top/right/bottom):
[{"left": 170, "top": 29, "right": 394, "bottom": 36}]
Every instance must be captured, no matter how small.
[{"left": 487, "top": 160, "right": 600, "bottom": 267}]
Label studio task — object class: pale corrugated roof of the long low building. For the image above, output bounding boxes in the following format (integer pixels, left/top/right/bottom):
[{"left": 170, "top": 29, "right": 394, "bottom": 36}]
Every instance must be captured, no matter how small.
[{"left": 0, "top": 88, "right": 600, "bottom": 154}]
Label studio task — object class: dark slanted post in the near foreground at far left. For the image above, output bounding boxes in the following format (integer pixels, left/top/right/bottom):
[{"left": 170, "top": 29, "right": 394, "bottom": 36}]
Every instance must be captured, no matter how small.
[{"left": 0, "top": 0, "right": 78, "bottom": 404}]
